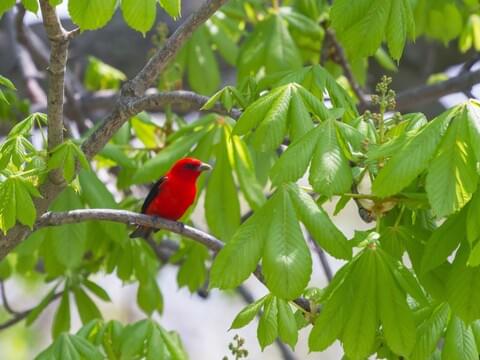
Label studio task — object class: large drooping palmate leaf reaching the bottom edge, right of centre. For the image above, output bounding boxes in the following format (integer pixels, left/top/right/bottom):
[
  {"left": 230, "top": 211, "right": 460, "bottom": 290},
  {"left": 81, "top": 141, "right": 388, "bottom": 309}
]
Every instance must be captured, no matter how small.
[{"left": 309, "top": 245, "right": 416, "bottom": 359}]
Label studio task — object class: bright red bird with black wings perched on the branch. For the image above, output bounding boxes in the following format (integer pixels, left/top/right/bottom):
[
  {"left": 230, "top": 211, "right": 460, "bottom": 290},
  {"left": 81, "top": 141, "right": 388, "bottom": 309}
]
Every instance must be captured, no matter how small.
[{"left": 130, "top": 158, "right": 212, "bottom": 238}]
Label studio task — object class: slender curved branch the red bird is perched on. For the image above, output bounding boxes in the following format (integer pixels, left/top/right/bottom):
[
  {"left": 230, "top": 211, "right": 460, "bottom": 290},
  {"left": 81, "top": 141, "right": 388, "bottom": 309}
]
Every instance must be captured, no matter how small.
[{"left": 35, "top": 209, "right": 310, "bottom": 312}]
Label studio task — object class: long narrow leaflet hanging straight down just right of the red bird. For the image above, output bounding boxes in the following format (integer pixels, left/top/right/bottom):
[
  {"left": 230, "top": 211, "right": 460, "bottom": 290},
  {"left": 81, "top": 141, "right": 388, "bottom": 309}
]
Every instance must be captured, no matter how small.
[{"left": 205, "top": 127, "right": 240, "bottom": 241}]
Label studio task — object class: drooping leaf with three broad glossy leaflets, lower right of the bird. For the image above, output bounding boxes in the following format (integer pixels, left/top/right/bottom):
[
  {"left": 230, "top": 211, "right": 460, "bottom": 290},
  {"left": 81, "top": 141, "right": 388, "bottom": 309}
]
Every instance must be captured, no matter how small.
[{"left": 211, "top": 185, "right": 351, "bottom": 300}]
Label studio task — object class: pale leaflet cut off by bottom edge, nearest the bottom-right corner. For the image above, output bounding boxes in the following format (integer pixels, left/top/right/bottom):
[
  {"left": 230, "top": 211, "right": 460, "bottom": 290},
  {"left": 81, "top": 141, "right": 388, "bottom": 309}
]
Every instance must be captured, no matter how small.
[{"left": 442, "top": 316, "right": 478, "bottom": 360}]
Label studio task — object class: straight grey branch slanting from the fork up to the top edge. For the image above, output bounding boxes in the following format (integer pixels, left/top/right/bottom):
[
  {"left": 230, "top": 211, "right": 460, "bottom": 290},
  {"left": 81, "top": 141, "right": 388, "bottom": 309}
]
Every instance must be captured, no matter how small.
[{"left": 124, "top": 0, "right": 227, "bottom": 96}]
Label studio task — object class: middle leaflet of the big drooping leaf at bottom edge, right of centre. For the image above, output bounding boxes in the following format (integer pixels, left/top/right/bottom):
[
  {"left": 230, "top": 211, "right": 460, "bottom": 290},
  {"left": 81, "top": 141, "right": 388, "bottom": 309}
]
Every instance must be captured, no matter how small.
[{"left": 342, "top": 249, "right": 378, "bottom": 359}]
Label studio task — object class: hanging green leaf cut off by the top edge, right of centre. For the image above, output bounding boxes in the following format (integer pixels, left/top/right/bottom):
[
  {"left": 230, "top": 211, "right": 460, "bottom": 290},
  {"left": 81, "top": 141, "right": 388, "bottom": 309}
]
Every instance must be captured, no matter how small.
[{"left": 331, "top": 0, "right": 415, "bottom": 60}]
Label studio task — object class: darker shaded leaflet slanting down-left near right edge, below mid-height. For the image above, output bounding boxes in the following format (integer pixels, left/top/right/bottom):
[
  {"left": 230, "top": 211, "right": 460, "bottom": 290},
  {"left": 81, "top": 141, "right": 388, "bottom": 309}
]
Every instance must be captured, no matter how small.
[{"left": 421, "top": 211, "right": 465, "bottom": 274}]
